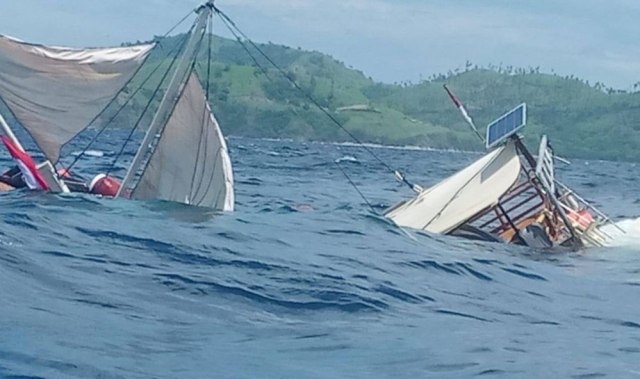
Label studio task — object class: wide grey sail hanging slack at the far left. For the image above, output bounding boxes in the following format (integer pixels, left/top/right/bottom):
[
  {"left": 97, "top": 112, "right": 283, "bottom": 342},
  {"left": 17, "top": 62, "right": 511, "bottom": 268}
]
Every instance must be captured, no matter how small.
[{"left": 0, "top": 35, "right": 153, "bottom": 162}]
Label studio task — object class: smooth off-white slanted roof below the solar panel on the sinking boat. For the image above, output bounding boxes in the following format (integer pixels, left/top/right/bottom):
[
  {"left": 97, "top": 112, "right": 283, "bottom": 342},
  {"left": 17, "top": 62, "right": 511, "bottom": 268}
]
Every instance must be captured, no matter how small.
[{"left": 385, "top": 142, "right": 521, "bottom": 233}]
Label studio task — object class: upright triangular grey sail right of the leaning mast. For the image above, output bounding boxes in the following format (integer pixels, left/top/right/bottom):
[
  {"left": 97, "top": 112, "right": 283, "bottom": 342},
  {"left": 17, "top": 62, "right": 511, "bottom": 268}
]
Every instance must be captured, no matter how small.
[{"left": 131, "top": 73, "right": 234, "bottom": 211}]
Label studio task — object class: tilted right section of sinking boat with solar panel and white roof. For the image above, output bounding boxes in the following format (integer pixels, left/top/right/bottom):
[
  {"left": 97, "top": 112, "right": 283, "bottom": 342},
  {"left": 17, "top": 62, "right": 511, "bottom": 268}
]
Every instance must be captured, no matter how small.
[{"left": 385, "top": 101, "right": 615, "bottom": 250}]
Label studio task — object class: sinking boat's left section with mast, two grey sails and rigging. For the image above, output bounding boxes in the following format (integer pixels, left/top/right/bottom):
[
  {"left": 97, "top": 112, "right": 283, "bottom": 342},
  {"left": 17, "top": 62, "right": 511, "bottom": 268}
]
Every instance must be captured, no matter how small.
[{"left": 0, "top": 0, "right": 234, "bottom": 211}]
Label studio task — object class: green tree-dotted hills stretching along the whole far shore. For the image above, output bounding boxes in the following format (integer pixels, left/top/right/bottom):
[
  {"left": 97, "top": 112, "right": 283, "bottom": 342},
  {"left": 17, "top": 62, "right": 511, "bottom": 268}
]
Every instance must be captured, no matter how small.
[{"left": 126, "top": 37, "right": 640, "bottom": 161}]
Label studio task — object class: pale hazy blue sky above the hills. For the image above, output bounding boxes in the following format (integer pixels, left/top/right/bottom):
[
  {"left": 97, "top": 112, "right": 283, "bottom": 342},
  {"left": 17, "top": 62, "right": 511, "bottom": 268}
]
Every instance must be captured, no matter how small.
[{"left": 0, "top": 0, "right": 640, "bottom": 89}]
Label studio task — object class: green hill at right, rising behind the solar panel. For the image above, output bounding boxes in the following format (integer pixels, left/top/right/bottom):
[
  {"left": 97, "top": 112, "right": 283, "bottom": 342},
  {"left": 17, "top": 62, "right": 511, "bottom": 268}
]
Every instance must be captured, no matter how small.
[{"left": 370, "top": 69, "right": 640, "bottom": 161}]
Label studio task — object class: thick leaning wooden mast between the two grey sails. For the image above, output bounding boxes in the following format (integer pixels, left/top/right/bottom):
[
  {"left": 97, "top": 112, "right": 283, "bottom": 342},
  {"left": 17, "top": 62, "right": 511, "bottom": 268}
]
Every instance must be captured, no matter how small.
[{"left": 116, "top": 0, "right": 214, "bottom": 196}]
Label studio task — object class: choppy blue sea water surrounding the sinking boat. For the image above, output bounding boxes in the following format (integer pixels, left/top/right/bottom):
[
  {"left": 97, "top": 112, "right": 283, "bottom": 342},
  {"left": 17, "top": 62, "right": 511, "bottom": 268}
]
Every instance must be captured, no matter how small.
[{"left": 0, "top": 139, "right": 640, "bottom": 378}]
